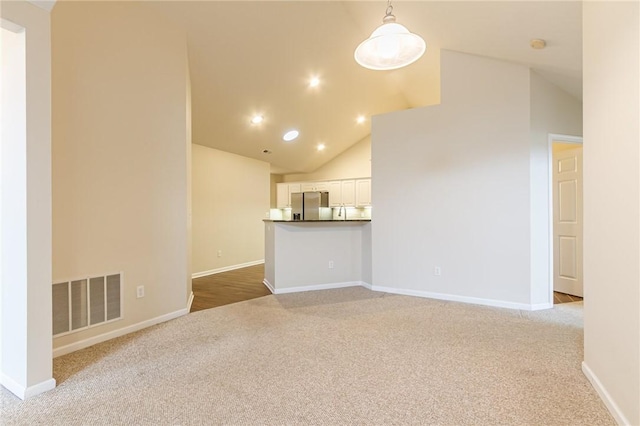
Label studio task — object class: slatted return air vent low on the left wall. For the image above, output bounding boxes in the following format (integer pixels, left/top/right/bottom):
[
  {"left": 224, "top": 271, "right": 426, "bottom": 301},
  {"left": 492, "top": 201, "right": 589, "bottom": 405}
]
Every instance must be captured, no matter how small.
[{"left": 52, "top": 273, "right": 122, "bottom": 336}]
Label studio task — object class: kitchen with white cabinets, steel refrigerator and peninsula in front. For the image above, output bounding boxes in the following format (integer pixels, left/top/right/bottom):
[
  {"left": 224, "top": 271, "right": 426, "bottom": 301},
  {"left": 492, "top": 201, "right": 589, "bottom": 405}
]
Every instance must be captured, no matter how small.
[{"left": 264, "top": 178, "right": 372, "bottom": 294}]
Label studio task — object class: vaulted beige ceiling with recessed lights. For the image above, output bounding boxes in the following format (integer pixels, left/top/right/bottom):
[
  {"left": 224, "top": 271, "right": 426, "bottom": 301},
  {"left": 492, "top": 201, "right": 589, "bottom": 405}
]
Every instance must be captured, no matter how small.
[{"left": 146, "top": 1, "right": 582, "bottom": 173}]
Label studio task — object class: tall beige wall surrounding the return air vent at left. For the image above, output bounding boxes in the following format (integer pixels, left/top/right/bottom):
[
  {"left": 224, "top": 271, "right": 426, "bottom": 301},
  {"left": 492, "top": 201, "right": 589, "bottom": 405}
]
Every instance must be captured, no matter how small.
[{"left": 48, "top": 2, "right": 190, "bottom": 347}]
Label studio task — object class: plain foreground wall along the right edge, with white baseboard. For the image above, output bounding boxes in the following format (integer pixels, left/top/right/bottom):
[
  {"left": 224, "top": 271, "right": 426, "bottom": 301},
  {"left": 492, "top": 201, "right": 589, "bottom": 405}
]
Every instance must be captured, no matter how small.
[{"left": 582, "top": 2, "right": 640, "bottom": 425}]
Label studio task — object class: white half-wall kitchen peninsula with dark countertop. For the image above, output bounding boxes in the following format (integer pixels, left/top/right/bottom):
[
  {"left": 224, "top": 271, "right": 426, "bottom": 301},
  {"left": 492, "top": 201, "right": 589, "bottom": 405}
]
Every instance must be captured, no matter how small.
[{"left": 264, "top": 219, "right": 371, "bottom": 294}]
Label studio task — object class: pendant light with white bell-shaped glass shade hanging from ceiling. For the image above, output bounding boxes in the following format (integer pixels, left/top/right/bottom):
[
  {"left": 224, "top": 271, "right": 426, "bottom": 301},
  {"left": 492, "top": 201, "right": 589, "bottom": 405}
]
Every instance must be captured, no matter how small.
[{"left": 354, "top": 0, "right": 427, "bottom": 70}]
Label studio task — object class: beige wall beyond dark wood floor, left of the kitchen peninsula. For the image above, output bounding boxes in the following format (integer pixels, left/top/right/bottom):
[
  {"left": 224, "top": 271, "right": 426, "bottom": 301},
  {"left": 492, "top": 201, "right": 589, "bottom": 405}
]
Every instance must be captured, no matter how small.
[{"left": 192, "top": 144, "right": 270, "bottom": 275}]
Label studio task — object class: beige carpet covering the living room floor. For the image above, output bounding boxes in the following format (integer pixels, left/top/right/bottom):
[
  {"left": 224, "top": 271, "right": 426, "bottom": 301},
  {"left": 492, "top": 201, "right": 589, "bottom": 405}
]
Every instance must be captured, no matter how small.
[{"left": 0, "top": 288, "right": 615, "bottom": 425}]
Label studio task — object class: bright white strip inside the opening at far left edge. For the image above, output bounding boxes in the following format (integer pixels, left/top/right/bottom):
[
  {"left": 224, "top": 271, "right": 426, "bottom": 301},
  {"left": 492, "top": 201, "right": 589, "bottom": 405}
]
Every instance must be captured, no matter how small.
[{"left": 0, "top": 21, "right": 27, "bottom": 396}]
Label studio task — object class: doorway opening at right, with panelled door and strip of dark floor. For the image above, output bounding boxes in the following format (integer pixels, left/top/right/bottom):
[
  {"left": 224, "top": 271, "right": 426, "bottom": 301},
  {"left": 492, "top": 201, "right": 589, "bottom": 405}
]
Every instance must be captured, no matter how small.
[{"left": 549, "top": 135, "right": 584, "bottom": 304}]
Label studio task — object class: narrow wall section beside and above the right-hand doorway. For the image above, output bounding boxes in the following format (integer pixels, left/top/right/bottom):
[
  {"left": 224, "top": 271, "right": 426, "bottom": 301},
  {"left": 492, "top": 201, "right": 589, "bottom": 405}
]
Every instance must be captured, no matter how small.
[{"left": 529, "top": 71, "right": 582, "bottom": 307}]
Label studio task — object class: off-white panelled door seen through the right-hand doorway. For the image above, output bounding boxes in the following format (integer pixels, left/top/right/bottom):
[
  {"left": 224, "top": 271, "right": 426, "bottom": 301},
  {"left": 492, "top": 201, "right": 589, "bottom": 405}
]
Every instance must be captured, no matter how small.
[{"left": 553, "top": 146, "right": 583, "bottom": 297}]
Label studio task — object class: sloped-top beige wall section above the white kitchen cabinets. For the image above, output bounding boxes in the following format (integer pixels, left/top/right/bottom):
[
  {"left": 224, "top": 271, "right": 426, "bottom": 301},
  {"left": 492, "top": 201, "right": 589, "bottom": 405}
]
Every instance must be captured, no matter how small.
[{"left": 284, "top": 136, "right": 371, "bottom": 182}]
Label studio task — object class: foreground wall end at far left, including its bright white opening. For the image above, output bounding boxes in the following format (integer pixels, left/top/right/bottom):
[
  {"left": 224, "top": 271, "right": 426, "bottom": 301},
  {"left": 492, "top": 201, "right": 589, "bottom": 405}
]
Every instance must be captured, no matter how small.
[{"left": 0, "top": 1, "right": 55, "bottom": 399}]
